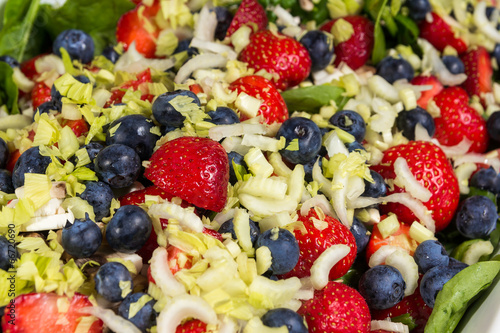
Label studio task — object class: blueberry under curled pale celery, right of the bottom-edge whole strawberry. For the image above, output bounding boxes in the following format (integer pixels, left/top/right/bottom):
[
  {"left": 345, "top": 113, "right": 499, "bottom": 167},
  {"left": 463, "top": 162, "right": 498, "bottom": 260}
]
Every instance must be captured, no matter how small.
[{"left": 359, "top": 265, "right": 406, "bottom": 310}]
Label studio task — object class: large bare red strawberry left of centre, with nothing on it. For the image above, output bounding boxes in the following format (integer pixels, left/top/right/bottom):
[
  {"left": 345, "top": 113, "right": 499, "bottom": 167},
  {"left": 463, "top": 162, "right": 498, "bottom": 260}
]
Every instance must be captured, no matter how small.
[{"left": 145, "top": 137, "right": 229, "bottom": 212}]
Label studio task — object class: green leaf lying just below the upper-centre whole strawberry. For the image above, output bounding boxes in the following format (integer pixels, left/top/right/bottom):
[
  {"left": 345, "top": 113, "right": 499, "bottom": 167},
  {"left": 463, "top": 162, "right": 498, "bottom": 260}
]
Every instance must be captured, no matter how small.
[{"left": 281, "top": 84, "right": 348, "bottom": 113}]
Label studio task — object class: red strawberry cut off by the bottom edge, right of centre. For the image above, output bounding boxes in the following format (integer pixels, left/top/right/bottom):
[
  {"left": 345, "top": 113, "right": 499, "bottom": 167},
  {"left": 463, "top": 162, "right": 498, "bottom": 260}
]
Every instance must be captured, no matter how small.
[{"left": 297, "top": 281, "right": 371, "bottom": 333}]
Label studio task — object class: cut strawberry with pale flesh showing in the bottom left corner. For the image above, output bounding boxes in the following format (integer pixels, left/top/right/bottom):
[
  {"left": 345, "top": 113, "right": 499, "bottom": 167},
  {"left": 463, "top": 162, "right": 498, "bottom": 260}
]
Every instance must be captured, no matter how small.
[{"left": 2, "top": 293, "right": 103, "bottom": 333}]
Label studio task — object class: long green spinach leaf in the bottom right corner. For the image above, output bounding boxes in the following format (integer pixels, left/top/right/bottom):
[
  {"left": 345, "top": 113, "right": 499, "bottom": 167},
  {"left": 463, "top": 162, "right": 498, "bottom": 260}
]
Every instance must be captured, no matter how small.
[{"left": 425, "top": 261, "right": 500, "bottom": 333}]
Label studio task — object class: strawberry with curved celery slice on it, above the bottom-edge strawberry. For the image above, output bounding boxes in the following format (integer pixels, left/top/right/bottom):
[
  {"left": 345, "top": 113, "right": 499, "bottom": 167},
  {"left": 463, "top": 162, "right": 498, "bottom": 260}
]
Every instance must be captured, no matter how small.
[{"left": 283, "top": 209, "right": 357, "bottom": 280}]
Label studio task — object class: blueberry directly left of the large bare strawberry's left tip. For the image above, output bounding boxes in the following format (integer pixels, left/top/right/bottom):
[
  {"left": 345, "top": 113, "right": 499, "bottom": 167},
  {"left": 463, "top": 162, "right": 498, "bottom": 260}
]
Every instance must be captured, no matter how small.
[{"left": 94, "top": 144, "right": 141, "bottom": 188}]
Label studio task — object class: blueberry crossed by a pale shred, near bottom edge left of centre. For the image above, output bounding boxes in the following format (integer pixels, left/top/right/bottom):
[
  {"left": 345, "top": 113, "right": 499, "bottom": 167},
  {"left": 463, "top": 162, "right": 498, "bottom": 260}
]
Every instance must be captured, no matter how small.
[{"left": 118, "top": 293, "right": 156, "bottom": 333}]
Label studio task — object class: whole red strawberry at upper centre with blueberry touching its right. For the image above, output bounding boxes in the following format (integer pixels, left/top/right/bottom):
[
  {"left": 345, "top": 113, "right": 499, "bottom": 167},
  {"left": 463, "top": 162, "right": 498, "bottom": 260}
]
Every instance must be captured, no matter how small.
[{"left": 239, "top": 30, "right": 312, "bottom": 90}]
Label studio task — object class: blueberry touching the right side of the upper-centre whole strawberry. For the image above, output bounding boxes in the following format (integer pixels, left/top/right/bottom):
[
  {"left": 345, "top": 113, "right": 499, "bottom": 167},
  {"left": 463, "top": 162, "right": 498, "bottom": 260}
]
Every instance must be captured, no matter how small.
[{"left": 300, "top": 30, "right": 335, "bottom": 72}]
